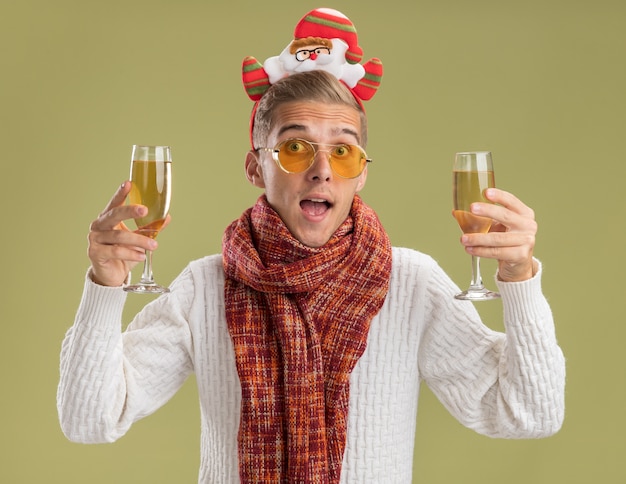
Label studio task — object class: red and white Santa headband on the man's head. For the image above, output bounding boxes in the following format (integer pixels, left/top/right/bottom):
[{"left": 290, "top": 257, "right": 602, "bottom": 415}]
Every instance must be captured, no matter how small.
[{"left": 242, "top": 8, "right": 383, "bottom": 148}]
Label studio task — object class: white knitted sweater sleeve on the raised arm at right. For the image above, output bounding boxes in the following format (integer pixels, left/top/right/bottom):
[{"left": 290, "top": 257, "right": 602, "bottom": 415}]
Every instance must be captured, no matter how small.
[{"left": 419, "top": 260, "right": 565, "bottom": 438}]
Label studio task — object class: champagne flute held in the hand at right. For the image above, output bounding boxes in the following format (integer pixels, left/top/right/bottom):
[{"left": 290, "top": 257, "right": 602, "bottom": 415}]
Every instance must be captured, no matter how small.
[{"left": 453, "top": 151, "right": 500, "bottom": 301}]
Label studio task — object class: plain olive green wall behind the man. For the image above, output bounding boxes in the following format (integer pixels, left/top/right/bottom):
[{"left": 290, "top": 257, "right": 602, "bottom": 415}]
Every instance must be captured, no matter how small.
[{"left": 0, "top": 0, "right": 626, "bottom": 484}]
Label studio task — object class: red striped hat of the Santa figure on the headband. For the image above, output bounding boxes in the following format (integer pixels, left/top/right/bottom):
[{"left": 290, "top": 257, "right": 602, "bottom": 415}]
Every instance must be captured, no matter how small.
[{"left": 293, "top": 8, "right": 363, "bottom": 64}]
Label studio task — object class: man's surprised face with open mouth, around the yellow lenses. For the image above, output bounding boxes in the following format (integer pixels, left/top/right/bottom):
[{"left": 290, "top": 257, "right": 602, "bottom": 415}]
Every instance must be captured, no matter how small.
[{"left": 246, "top": 102, "right": 367, "bottom": 247}]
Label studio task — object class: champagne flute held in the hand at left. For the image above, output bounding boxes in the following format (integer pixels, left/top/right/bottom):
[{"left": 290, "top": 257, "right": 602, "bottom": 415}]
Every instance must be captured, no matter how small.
[{"left": 124, "top": 145, "right": 172, "bottom": 294}]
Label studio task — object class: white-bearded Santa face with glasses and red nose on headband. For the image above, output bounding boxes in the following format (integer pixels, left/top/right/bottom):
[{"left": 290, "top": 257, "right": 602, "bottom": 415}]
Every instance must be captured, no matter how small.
[{"left": 279, "top": 39, "right": 348, "bottom": 78}]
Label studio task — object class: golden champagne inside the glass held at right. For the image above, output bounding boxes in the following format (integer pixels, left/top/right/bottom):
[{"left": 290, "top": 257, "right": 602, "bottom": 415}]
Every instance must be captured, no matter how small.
[{"left": 453, "top": 170, "right": 495, "bottom": 234}]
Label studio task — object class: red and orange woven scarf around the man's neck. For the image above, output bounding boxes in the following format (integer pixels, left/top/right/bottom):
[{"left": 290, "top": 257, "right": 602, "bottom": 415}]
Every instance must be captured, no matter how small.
[{"left": 223, "top": 195, "right": 391, "bottom": 484}]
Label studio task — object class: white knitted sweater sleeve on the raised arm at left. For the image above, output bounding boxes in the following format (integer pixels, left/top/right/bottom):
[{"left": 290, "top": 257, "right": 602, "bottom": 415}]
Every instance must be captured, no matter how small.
[{"left": 57, "top": 271, "right": 193, "bottom": 443}]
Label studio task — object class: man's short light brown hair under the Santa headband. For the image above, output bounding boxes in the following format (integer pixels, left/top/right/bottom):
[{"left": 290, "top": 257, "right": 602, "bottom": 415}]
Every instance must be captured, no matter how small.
[{"left": 252, "top": 70, "right": 367, "bottom": 148}]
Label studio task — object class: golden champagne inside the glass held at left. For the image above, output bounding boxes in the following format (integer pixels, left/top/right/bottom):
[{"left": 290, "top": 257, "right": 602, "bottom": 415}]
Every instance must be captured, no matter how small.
[{"left": 129, "top": 160, "right": 172, "bottom": 239}]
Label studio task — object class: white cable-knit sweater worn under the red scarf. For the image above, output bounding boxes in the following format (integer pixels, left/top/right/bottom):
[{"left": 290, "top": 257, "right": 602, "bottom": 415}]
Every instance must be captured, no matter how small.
[{"left": 57, "top": 248, "right": 565, "bottom": 484}]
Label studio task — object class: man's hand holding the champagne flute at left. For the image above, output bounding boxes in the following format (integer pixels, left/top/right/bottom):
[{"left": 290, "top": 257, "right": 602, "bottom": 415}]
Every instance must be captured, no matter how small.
[{"left": 88, "top": 181, "right": 169, "bottom": 286}]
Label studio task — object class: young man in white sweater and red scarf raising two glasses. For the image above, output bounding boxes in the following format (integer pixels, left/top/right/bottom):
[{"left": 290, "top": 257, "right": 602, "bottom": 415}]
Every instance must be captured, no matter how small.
[{"left": 58, "top": 11, "right": 564, "bottom": 484}]
